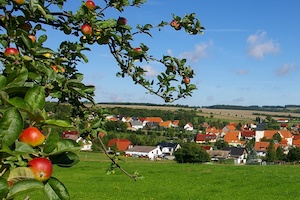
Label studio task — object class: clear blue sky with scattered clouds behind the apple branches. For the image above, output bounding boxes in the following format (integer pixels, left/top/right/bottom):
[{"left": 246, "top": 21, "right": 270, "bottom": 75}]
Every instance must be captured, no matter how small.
[{"left": 55, "top": 0, "right": 300, "bottom": 106}]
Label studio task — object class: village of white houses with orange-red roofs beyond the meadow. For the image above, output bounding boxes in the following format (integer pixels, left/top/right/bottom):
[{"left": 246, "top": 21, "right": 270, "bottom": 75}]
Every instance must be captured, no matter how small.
[{"left": 62, "top": 113, "right": 300, "bottom": 164}]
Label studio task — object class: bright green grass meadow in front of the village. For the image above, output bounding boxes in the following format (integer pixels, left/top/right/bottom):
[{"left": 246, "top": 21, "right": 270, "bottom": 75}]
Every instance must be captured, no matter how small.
[{"left": 17, "top": 153, "right": 300, "bottom": 200}]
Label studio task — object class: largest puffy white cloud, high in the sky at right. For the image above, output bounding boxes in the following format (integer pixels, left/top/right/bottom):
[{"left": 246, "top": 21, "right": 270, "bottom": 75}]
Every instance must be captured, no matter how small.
[{"left": 247, "top": 31, "right": 280, "bottom": 59}]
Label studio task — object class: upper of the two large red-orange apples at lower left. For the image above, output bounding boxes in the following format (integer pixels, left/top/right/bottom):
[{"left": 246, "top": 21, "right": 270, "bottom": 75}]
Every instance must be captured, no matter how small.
[{"left": 19, "top": 126, "right": 45, "bottom": 147}]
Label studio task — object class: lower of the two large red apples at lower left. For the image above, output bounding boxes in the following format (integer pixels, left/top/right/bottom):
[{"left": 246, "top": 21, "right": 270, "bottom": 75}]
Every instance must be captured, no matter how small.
[{"left": 28, "top": 157, "right": 52, "bottom": 181}]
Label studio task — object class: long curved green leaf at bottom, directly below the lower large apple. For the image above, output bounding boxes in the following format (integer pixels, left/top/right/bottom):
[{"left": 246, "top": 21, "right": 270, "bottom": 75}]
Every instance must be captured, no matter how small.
[{"left": 7, "top": 179, "right": 44, "bottom": 199}]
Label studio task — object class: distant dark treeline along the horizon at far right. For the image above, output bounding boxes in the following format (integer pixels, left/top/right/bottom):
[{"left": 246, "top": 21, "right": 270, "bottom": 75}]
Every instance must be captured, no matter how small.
[{"left": 202, "top": 105, "right": 300, "bottom": 113}]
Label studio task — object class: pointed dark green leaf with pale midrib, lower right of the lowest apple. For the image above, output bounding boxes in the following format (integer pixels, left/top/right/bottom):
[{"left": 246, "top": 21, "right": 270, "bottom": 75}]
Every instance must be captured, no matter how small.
[{"left": 44, "top": 177, "right": 70, "bottom": 200}]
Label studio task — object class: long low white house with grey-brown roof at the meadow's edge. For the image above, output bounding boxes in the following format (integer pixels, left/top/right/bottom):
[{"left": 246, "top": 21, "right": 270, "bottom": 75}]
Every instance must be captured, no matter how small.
[{"left": 125, "top": 146, "right": 162, "bottom": 160}]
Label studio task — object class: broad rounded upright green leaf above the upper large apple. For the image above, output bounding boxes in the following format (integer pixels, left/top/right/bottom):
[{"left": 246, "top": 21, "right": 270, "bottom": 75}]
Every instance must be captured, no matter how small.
[{"left": 24, "top": 85, "right": 46, "bottom": 111}]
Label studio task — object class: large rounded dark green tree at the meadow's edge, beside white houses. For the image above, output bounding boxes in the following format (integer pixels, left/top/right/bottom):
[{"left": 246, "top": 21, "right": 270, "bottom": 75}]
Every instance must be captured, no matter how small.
[{"left": 174, "top": 143, "right": 210, "bottom": 163}]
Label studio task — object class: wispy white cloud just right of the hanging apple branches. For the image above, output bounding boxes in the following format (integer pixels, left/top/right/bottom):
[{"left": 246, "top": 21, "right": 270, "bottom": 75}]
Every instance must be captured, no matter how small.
[{"left": 179, "top": 42, "right": 213, "bottom": 62}]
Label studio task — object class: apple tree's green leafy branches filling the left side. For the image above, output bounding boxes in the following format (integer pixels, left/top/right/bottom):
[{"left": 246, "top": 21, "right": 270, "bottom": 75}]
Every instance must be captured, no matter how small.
[{"left": 0, "top": 0, "right": 204, "bottom": 199}]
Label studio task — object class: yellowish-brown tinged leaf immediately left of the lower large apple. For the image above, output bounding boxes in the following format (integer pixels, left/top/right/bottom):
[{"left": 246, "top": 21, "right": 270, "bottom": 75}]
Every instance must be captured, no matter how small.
[{"left": 7, "top": 167, "right": 34, "bottom": 183}]
